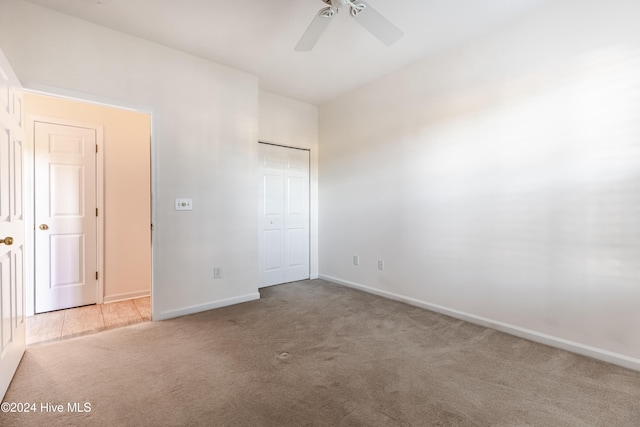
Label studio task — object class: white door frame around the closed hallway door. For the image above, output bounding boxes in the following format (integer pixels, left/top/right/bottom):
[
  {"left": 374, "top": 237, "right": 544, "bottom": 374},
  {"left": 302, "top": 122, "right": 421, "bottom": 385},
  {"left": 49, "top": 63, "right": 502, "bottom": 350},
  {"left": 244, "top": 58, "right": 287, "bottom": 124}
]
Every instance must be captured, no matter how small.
[{"left": 24, "top": 115, "right": 105, "bottom": 316}]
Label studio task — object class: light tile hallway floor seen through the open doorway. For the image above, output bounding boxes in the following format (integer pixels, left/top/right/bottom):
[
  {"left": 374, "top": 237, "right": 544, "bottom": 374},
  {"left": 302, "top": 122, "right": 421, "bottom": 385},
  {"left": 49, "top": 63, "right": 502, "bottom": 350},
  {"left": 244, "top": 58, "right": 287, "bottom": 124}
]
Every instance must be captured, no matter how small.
[{"left": 27, "top": 297, "right": 151, "bottom": 345}]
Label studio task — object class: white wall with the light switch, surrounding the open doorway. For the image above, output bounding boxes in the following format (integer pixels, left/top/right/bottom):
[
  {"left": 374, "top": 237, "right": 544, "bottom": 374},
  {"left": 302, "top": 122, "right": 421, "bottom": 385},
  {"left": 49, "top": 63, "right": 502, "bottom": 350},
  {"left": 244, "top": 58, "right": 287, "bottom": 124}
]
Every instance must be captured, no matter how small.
[{"left": 0, "top": 0, "right": 259, "bottom": 319}]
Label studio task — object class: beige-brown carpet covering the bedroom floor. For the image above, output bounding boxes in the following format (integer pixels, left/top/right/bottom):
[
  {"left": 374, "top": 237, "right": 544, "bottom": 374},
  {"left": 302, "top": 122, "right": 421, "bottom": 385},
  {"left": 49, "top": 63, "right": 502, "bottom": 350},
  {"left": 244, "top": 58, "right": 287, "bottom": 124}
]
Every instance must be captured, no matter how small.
[{"left": 0, "top": 280, "right": 640, "bottom": 426}]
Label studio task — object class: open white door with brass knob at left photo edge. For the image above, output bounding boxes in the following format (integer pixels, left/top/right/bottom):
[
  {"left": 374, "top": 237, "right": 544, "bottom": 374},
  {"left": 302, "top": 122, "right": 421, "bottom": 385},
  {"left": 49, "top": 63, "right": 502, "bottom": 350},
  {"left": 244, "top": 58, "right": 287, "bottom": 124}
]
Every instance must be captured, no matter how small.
[{"left": 0, "top": 51, "right": 25, "bottom": 401}]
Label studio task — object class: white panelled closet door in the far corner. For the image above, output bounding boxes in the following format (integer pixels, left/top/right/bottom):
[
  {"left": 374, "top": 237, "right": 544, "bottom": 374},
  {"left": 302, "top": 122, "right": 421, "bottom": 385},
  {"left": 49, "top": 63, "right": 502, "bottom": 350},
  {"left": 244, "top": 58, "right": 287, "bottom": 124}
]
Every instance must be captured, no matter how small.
[{"left": 259, "top": 144, "right": 309, "bottom": 286}]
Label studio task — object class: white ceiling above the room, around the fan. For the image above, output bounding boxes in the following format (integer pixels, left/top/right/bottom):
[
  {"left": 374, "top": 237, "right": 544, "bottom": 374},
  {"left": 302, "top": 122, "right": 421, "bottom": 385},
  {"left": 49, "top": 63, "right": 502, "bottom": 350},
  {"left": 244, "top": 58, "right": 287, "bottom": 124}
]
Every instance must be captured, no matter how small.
[{"left": 23, "top": 0, "right": 550, "bottom": 104}]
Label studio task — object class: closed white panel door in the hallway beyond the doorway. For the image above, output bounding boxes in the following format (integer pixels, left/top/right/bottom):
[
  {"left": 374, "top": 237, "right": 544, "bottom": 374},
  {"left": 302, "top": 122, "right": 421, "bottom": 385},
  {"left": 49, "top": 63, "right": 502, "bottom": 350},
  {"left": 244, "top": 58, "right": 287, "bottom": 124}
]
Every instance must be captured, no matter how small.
[{"left": 34, "top": 122, "right": 98, "bottom": 313}]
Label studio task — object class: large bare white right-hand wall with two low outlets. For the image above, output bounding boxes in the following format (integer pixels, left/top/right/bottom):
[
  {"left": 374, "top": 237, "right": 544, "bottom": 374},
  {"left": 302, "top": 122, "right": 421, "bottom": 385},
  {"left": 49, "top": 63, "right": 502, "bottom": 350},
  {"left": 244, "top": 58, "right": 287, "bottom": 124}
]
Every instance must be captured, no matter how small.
[{"left": 319, "top": 0, "right": 640, "bottom": 369}]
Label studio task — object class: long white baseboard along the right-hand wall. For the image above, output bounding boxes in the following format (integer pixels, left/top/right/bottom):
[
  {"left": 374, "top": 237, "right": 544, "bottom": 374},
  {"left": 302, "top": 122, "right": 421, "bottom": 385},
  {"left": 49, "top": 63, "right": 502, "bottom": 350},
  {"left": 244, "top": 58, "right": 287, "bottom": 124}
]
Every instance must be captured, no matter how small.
[{"left": 320, "top": 274, "right": 640, "bottom": 371}]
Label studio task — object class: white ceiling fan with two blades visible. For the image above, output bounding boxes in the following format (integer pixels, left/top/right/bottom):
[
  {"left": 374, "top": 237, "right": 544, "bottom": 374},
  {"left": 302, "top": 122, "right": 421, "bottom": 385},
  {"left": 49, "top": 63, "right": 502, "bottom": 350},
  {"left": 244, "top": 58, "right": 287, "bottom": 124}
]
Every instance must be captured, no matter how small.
[{"left": 296, "top": 0, "right": 403, "bottom": 52}]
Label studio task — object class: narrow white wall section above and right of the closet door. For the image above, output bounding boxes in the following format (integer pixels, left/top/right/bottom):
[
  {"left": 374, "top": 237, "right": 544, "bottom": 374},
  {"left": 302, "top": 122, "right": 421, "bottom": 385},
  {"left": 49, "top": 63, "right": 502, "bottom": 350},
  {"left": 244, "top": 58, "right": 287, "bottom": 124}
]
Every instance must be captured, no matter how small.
[{"left": 258, "top": 91, "right": 318, "bottom": 279}]
